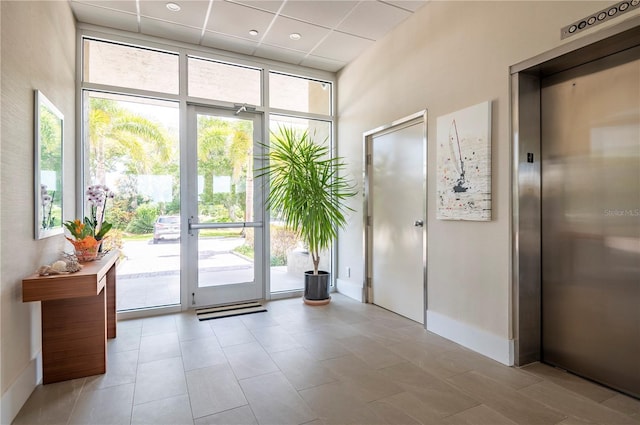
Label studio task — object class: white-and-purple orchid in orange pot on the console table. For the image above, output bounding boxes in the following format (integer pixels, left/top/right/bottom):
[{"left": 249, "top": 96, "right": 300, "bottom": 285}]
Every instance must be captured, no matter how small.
[{"left": 64, "top": 184, "right": 114, "bottom": 241}]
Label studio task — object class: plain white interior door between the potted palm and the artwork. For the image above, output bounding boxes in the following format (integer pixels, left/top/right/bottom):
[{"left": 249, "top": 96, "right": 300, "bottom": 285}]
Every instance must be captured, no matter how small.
[{"left": 368, "top": 114, "right": 426, "bottom": 323}]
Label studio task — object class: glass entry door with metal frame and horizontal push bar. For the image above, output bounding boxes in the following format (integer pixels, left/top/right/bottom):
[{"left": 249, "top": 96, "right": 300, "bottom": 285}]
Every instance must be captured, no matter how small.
[{"left": 183, "top": 106, "right": 264, "bottom": 306}]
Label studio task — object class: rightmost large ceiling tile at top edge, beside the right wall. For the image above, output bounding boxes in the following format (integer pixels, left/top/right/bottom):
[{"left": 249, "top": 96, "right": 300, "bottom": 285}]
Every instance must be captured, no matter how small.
[{"left": 338, "top": 1, "right": 411, "bottom": 40}]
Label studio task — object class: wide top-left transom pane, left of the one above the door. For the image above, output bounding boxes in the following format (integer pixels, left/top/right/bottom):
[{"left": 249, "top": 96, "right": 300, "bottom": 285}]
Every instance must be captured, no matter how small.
[{"left": 83, "top": 39, "right": 179, "bottom": 94}]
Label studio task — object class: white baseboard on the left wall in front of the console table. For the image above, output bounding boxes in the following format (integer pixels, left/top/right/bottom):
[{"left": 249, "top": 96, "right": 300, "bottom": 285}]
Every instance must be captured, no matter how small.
[{"left": 0, "top": 351, "right": 42, "bottom": 424}]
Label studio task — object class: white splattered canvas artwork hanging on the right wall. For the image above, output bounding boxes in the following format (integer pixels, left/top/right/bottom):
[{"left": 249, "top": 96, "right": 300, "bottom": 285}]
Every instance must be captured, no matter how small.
[{"left": 436, "top": 101, "right": 491, "bottom": 221}]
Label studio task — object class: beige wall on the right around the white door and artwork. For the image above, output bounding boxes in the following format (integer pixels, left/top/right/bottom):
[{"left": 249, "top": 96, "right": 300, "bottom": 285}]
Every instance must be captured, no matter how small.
[{"left": 337, "top": 1, "right": 639, "bottom": 364}]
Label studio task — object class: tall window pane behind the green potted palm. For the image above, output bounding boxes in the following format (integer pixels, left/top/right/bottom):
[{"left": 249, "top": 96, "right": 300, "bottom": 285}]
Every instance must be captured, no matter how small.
[{"left": 269, "top": 115, "right": 331, "bottom": 292}]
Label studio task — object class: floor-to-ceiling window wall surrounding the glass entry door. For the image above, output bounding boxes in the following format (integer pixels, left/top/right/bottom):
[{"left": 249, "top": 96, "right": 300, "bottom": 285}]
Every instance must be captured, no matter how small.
[{"left": 78, "top": 29, "right": 334, "bottom": 311}]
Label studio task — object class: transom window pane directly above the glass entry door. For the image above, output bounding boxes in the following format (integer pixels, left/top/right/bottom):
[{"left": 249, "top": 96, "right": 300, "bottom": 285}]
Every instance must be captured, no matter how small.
[{"left": 188, "top": 57, "right": 262, "bottom": 105}]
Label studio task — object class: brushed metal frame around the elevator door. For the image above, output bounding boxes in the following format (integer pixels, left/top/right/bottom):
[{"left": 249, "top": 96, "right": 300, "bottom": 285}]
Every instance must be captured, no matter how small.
[{"left": 510, "top": 16, "right": 640, "bottom": 366}]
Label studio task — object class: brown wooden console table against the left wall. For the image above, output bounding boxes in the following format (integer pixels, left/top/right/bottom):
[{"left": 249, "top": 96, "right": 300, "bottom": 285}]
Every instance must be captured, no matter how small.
[{"left": 22, "top": 251, "right": 118, "bottom": 384}]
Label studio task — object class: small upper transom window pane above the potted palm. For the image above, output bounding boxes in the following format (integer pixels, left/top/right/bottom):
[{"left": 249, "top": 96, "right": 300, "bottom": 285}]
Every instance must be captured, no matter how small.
[{"left": 269, "top": 72, "right": 331, "bottom": 115}]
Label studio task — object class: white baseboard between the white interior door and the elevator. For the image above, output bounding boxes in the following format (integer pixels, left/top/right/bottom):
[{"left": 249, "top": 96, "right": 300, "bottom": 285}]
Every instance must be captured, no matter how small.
[{"left": 427, "top": 311, "right": 514, "bottom": 366}]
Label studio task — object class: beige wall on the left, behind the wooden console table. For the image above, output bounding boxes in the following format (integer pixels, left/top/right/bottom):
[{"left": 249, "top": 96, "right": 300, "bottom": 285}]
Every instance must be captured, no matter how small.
[{"left": 0, "top": 0, "right": 76, "bottom": 424}]
